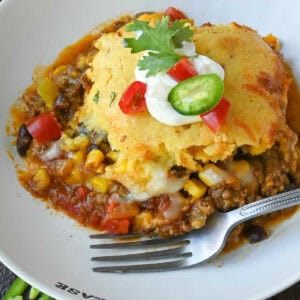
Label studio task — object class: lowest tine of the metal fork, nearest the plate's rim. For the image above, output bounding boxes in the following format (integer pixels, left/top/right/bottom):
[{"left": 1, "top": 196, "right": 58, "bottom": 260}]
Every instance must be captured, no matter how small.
[{"left": 93, "top": 259, "right": 188, "bottom": 273}]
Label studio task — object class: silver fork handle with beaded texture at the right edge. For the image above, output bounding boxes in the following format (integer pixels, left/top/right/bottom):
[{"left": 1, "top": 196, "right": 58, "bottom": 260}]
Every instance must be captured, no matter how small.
[{"left": 229, "top": 188, "right": 300, "bottom": 223}]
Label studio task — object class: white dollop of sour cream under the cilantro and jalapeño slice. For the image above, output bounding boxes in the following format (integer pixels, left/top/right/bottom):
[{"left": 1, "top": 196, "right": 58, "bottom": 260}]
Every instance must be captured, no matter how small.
[{"left": 135, "top": 42, "right": 224, "bottom": 126}]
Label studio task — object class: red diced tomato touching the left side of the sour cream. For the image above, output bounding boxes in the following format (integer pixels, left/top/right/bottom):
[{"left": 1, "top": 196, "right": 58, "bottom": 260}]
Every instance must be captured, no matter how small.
[{"left": 119, "top": 81, "right": 147, "bottom": 114}]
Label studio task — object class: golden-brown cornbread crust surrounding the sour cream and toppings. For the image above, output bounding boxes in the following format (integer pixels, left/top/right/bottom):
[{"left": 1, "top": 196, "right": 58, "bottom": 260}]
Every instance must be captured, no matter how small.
[{"left": 77, "top": 16, "right": 296, "bottom": 170}]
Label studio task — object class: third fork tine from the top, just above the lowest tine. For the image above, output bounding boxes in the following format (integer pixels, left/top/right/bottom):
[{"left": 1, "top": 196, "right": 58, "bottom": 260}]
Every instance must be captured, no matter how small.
[{"left": 91, "top": 246, "right": 192, "bottom": 261}]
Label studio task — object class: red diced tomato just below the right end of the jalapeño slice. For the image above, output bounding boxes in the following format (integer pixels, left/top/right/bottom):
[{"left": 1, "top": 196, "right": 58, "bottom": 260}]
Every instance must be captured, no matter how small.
[{"left": 200, "top": 97, "right": 231, "bottom": 132}]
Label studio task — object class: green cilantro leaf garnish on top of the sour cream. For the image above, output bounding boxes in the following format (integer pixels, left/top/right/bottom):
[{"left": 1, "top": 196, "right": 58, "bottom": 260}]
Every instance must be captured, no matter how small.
[{"left": 125, "top": 17, "right": 193, "bottom": 77}]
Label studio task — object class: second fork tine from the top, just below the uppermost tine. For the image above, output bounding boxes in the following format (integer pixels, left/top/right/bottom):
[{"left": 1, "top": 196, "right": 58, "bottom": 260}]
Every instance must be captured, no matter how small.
[{"left": 90, "top": 237, "right": 190, "bottom": 249}]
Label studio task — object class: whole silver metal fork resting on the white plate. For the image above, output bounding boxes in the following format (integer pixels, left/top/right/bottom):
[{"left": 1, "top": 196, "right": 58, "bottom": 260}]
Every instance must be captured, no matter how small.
[{"left": 90, "top": 188, "right": 300, "bottom": 272}]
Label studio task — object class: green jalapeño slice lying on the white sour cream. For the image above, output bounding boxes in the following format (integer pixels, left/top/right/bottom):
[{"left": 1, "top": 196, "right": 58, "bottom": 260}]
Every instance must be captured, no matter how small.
[{"left": 168, "top": 74, "right": 224, "bottom": 116}]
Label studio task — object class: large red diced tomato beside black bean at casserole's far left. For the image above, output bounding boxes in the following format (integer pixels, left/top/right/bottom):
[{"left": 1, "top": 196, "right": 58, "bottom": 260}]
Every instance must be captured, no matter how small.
[{"left": 26, "top": 112, "right": 61, "bottom": 144}]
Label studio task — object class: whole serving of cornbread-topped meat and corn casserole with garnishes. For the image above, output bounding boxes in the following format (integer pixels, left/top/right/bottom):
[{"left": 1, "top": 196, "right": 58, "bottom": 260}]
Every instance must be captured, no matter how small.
[{"left": 9, "top": 8, "right": 299, "bottom": 246}]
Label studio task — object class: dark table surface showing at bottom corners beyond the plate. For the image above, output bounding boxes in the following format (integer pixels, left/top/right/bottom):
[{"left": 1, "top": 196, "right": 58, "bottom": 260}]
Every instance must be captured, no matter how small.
[{"left": 0, "top": 262, "right": 300, "bottom": 300}]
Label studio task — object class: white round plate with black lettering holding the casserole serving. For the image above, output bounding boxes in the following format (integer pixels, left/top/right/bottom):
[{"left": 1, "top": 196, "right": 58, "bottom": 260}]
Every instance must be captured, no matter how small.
[{"left": 0, "top": 0, "right": 300, "bottom": 300}]
